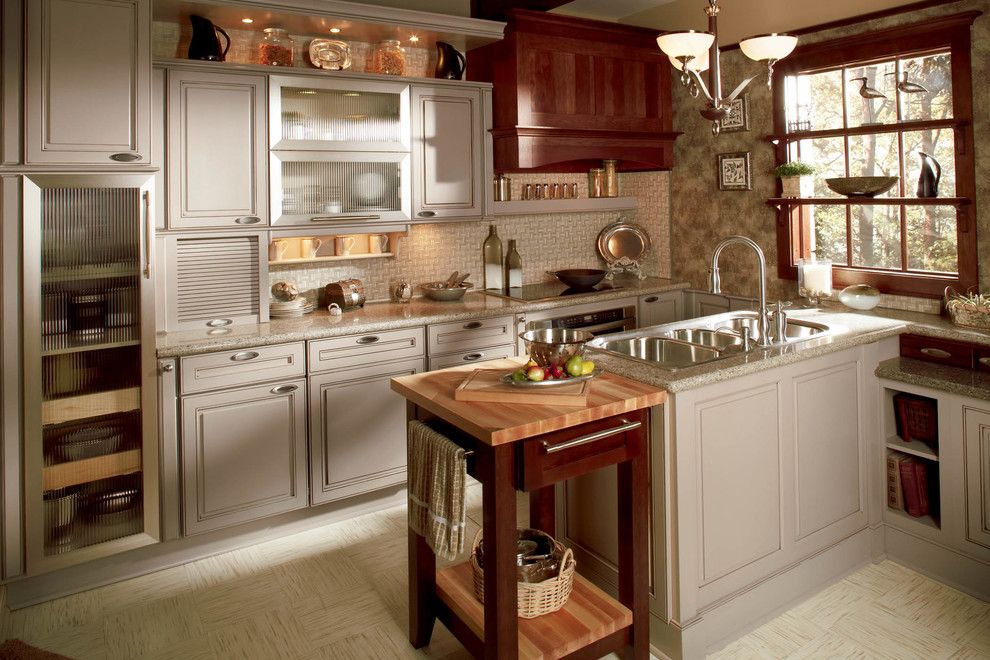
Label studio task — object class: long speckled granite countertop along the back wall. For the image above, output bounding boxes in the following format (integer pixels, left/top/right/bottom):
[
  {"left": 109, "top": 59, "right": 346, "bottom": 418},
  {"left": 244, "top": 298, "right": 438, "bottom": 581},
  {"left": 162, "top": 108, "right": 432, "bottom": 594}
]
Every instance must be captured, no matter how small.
[{"left": 156, "top": 277, "right": 690, "bottom": 358}]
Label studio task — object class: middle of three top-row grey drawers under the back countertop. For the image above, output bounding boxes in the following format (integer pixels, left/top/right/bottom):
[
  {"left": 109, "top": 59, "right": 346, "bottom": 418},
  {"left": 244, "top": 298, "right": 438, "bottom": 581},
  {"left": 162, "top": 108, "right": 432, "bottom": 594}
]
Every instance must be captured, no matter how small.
[{"left": 309, "top": 328, "right": 426, "bottom": 373}]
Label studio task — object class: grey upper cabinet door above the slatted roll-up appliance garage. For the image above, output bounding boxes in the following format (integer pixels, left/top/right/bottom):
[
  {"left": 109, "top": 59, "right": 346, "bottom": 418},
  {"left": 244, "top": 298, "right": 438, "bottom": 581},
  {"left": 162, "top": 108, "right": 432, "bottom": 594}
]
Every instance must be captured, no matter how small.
[{"left": 167, "top": 70, "right": 268, "bottom": 228}]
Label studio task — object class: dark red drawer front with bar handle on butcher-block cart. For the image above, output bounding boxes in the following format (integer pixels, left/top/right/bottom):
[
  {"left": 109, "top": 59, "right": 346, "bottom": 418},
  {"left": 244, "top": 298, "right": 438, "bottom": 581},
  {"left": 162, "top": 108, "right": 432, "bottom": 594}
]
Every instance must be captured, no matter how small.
[{"left": 517, "top": 410, "right": 649, "bottom": 492}]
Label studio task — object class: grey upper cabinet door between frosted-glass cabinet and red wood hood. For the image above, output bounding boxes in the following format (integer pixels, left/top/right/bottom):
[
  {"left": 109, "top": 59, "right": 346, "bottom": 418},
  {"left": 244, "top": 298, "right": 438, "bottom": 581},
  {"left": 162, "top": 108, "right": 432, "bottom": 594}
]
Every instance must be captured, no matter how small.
[{"left": 412, "top": 87, "right": 484, "bottom": 220}]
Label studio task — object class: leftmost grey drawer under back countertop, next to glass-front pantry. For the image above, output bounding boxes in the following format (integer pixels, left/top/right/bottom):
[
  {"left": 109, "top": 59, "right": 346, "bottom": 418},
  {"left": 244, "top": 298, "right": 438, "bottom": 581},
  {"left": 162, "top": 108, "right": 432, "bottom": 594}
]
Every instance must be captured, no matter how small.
[{"left": 179, "top": 342, "right": 306, "bottom": 394}]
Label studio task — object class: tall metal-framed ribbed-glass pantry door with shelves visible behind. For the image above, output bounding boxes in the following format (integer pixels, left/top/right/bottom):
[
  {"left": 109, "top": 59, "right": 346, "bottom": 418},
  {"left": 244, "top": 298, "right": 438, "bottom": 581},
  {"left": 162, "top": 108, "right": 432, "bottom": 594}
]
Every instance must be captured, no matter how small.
[{"left": 23, "top": 174, "right": 159, "bottom": 574}]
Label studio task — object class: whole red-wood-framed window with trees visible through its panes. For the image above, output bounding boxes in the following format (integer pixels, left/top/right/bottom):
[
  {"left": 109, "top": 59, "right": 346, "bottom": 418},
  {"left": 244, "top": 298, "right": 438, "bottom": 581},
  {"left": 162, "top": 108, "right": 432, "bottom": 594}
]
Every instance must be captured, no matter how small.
[{"left": 774, "top": 12, "right": 978, "bottom": 296}]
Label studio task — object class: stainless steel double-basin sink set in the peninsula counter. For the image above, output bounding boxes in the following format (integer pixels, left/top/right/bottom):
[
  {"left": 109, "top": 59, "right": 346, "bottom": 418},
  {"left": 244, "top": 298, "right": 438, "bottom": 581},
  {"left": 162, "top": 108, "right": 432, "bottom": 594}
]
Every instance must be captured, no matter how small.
[{"left": 588, "top": 312, "right": 830, "bottom": 370}]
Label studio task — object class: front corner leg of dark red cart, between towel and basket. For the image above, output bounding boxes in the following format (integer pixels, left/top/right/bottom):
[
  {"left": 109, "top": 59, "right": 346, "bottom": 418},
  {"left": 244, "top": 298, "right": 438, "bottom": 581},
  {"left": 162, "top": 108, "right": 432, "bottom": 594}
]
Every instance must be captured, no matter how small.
[{"left": 477, "top": 444, "right": 519, "bottom": 660}]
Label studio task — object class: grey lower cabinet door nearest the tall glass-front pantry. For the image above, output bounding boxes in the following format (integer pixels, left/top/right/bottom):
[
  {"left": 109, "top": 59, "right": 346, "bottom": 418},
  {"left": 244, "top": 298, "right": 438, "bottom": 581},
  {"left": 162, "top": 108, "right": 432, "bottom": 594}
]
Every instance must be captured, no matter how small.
[{"left": 181, "top": 378, "right": 306, "bottom": 535}]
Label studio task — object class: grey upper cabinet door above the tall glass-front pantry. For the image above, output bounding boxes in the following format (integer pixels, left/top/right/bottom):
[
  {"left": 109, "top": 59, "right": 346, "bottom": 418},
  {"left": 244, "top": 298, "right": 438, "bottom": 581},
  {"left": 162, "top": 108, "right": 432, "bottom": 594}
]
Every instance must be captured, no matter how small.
[{"left": 25, "top": 0, "right": 151, "bottom": 165}]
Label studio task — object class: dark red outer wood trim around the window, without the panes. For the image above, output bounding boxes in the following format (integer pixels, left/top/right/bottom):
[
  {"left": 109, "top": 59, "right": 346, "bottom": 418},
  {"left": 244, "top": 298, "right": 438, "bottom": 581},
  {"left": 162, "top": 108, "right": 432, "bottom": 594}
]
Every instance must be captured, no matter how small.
[{"left": 771, "top": 11, "right": 982, "bottom": 298}]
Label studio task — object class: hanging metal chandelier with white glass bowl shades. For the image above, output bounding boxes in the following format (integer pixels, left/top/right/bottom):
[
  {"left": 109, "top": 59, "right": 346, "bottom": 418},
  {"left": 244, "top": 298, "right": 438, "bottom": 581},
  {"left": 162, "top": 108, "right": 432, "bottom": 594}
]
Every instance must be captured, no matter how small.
[{"left": 657, "top": 0, "right": 797, "bottom": 135}]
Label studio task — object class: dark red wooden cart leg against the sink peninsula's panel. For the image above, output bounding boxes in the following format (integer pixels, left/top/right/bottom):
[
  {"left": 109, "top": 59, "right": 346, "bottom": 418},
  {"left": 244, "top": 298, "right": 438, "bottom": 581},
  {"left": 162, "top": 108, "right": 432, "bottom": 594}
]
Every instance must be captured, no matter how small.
[{"left": 617, "top": 421, "right": 650, "bottom": 660}]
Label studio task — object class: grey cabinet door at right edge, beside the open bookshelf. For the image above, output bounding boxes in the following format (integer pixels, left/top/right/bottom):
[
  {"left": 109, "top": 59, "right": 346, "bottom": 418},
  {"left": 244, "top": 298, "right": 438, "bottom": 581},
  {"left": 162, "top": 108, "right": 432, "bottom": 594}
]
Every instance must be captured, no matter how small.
[{"left": 963, "top": 408, "right": 990, "bottom": 548}]
